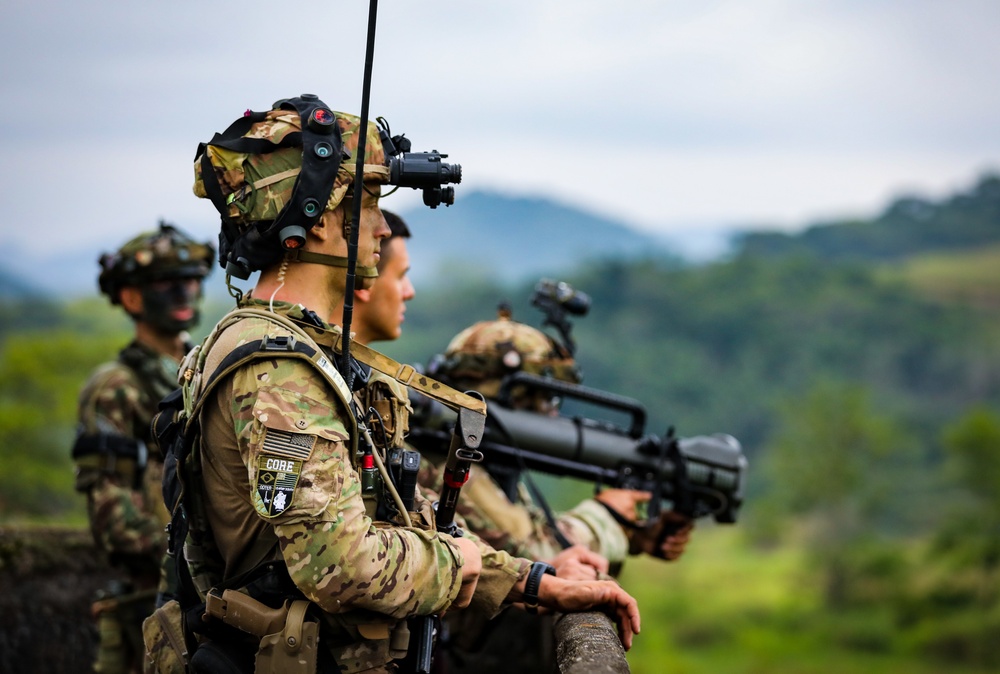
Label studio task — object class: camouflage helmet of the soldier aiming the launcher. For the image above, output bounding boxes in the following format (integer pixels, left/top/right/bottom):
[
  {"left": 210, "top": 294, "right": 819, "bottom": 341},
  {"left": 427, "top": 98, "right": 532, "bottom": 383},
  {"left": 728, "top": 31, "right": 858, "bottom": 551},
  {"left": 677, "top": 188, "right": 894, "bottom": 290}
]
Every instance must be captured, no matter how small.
[{"left": 429, "top": 309, "right": 583, "bottom": 398}]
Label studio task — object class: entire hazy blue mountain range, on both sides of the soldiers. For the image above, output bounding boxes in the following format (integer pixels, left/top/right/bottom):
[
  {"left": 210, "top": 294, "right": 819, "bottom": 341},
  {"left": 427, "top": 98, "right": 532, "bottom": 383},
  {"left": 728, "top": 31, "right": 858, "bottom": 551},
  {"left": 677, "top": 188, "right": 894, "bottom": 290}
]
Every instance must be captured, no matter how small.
[{"left": 0, "top": 186, "right": 731, "bottom": 302}]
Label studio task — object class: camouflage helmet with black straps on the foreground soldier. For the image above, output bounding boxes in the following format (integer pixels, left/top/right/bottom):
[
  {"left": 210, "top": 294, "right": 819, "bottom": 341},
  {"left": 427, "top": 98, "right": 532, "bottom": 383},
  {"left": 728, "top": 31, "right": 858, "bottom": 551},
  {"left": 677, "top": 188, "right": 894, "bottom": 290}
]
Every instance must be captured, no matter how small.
[{"left": 194, "top": 94, "right": 389, "bottom": 279}]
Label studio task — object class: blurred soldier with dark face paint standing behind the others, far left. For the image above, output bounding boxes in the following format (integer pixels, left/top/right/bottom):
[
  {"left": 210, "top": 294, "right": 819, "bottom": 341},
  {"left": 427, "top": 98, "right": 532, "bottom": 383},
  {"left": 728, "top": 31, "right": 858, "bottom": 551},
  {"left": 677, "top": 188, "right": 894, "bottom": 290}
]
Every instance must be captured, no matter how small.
[{"left": 73, "top": 222, "right": 214, "bottom": 672}]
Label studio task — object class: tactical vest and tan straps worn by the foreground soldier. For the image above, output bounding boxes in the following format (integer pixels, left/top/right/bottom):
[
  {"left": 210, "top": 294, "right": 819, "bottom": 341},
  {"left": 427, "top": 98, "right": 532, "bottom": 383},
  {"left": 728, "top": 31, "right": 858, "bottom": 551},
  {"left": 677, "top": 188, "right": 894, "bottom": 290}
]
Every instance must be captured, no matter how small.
[{"left": 153, "top": 308, "right": 485, "bottom": 671}]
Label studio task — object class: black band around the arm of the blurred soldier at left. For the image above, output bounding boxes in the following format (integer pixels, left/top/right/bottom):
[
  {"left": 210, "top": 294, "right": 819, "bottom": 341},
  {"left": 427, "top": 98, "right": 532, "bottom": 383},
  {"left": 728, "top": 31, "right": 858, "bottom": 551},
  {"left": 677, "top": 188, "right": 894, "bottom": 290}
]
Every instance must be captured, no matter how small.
[{"left": 73, "top": 431, "right": 147, "bottom": 492}]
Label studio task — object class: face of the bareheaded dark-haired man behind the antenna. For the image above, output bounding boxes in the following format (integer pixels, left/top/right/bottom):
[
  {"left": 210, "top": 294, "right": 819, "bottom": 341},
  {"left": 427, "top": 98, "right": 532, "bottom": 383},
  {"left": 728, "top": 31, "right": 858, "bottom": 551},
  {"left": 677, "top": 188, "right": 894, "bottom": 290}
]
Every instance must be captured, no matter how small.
[{"left": 355, "top": 236, "right": 416, "bottom": 343}]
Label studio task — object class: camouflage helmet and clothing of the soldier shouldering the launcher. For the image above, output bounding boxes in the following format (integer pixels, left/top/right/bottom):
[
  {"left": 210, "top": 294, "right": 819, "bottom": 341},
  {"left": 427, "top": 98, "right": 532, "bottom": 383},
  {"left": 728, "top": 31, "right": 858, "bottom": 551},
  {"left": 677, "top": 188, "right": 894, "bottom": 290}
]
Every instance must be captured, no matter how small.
[{"left": 419, "top": 313, "right": 629, "bottom": 674}]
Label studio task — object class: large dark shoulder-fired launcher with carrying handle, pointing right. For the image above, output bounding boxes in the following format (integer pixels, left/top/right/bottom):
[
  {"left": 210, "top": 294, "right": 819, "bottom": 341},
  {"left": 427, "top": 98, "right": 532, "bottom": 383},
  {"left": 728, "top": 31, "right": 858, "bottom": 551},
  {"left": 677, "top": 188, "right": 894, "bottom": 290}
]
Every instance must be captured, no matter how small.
[{"left": 408, "top": 372, "right": 747, "bottom": 523}]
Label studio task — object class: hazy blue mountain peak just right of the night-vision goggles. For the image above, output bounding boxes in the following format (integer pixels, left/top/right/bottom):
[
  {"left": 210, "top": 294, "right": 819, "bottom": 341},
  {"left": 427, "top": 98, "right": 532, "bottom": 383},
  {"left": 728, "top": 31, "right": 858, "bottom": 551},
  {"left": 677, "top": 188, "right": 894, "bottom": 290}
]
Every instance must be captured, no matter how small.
[{"left": 400, "top": 191, "right": 678, "bottom": 281}]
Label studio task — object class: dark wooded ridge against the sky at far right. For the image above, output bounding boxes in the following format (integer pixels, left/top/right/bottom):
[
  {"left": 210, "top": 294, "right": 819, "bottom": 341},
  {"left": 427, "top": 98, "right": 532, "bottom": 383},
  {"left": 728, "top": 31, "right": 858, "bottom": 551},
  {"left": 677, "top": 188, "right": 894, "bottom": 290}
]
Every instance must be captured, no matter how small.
[{"left": 735, "top": 175, "right": 1000, "bottom": 260}]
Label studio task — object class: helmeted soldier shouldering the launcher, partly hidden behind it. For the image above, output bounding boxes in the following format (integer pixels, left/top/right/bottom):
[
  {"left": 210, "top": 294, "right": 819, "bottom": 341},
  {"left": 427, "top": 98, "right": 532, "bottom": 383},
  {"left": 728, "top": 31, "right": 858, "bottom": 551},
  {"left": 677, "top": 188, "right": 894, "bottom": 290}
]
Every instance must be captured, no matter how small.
[{"left": 420, "top": 303, "right": 693, "bottom": 674}]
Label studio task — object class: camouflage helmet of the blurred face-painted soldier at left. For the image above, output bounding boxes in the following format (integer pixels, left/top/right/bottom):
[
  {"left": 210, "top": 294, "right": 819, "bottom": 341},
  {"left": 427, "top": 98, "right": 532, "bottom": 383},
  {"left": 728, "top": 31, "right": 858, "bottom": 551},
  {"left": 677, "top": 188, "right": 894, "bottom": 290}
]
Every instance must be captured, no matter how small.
[{"left": 97, "top": 220, "right": 215, "bottom": 304}]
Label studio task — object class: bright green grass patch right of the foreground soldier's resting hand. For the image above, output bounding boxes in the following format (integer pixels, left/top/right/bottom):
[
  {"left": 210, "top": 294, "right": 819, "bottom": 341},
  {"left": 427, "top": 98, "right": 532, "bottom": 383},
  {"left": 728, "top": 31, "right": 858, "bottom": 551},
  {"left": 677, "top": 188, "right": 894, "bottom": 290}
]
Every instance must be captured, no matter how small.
[{"left": 621, "top": 524, "right": 988, "bottom": 674}]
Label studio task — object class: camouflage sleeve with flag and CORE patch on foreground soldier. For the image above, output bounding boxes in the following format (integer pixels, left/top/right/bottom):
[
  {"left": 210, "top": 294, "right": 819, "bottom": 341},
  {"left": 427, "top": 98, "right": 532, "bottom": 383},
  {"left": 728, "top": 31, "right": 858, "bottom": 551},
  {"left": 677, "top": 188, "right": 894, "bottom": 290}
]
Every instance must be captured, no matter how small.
[{"left": 234, "top": 360, "right": 464, "bottom": 618}]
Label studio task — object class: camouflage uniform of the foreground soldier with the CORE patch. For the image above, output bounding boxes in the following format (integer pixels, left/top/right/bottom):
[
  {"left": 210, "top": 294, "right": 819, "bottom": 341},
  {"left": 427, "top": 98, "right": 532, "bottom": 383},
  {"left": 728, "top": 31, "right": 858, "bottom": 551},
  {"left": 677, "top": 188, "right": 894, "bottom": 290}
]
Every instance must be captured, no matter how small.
[{"left": 188, "top": 300, "right": 529, "bottom": 673}]
